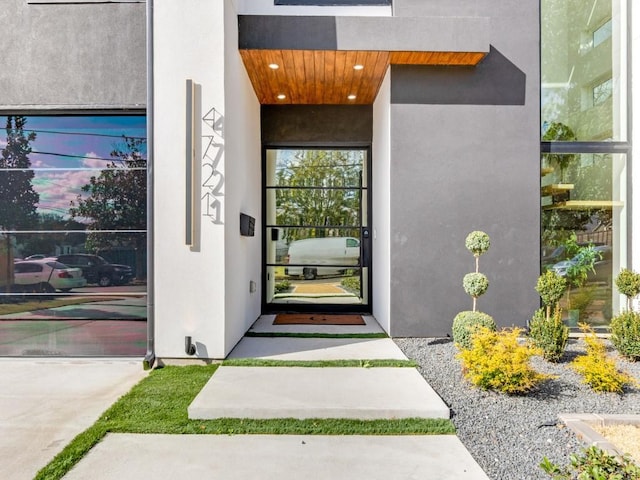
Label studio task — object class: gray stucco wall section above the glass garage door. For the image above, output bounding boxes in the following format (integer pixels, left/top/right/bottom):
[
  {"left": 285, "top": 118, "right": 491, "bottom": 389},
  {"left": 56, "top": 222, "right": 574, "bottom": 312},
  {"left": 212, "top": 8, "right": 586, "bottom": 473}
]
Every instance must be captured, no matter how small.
[{"left": 0, "top": 0, "right": 146, "bottom": 109}]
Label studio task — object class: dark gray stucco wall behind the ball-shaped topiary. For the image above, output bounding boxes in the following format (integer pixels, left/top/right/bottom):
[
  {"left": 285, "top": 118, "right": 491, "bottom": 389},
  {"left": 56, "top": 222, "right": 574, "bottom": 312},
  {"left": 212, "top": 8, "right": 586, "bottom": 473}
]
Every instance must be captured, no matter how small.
[{"left": 390, "top": 0, "right": 540, "bottom": 336}]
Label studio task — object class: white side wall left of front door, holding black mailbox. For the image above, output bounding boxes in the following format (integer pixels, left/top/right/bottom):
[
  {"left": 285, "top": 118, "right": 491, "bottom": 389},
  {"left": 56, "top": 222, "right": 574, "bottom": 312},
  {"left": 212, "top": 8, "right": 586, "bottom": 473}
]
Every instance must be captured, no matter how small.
[{"left": 224, "top": 0, "right": 262, "bottom": 355}]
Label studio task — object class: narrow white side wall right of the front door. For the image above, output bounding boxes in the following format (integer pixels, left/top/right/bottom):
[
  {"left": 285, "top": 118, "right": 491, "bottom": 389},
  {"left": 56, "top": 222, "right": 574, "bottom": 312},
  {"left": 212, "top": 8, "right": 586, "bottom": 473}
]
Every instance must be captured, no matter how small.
[{"left": 371, "top": 70, "right": 391, "bottom": 333}]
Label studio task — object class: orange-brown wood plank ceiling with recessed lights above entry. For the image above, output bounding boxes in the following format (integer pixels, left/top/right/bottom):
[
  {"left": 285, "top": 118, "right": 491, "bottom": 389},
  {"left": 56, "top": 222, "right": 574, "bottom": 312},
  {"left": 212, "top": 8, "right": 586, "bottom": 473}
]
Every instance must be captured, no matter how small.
[{"left": 240, "top": 49, "right": 486, "bottom": 105}]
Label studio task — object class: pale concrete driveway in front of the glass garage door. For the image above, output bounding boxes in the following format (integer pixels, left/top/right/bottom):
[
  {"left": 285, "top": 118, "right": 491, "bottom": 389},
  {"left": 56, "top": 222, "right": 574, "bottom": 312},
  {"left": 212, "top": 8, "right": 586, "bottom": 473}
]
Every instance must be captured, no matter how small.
[{"left": 0, "top": 358, "right": 146, "bottom": 480}]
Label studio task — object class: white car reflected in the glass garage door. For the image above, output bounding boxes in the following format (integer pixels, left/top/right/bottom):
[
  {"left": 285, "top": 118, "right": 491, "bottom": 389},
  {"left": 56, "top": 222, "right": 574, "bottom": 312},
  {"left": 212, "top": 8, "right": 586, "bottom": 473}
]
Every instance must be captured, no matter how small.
[{"left": 13, "top": 260, "right": 87, "bottom": 292}]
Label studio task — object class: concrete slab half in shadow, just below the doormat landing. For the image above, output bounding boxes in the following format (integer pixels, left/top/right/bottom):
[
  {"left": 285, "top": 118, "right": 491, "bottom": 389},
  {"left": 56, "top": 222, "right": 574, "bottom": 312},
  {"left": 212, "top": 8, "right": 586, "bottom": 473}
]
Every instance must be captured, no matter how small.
[{"left": 227, "top": 337, "right": 407, "bottom": 360}]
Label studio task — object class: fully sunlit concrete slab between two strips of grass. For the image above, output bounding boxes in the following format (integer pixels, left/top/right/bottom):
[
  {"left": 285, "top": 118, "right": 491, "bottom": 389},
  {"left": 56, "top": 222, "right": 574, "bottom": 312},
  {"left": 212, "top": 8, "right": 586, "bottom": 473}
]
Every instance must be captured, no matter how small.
[{"left": 188, "top": 366, "right": 450, "bottom": 419}]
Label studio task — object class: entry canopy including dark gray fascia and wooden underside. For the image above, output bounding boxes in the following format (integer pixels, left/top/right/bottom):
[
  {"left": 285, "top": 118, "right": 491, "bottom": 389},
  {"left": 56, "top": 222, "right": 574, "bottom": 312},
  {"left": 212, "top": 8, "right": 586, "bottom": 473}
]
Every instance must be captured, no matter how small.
[{"left": 238, "top": 15, "right": 489, "bottom": 105}]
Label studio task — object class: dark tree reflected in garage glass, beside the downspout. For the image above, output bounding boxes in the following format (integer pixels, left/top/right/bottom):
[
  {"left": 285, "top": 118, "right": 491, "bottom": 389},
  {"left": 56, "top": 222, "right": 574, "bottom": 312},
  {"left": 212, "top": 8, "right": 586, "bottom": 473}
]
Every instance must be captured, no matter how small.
[{"left": 69, "top": 136, "right": 147, "bottom": 277}]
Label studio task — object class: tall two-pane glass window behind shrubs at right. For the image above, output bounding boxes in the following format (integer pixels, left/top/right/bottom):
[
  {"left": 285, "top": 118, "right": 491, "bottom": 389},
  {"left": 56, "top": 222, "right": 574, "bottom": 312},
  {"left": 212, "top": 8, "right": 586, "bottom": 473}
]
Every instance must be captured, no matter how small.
[{"left": 541, "top": 0, "right": 631, "bottom": 326}]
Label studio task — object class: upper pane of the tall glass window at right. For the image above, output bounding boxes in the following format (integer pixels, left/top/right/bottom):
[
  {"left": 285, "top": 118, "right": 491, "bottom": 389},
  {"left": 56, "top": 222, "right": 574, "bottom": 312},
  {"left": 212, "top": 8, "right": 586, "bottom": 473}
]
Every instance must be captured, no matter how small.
[{"left": 541, "top": 0, "right": 627, "bottom": 142}]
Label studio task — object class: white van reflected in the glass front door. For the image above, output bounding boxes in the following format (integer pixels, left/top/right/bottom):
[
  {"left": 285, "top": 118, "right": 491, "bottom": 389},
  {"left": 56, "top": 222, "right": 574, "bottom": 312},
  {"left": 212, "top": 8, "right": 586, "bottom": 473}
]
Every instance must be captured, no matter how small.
[{"left": 285, "top": 237, "right": 360, "bottom": 280}]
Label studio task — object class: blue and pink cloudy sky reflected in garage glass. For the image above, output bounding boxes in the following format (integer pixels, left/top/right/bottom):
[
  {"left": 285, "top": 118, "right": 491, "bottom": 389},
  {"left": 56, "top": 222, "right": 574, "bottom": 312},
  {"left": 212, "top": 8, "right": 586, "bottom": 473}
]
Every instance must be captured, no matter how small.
[{"left": 0, "top": 115, "right": 146, "bottom": 218}]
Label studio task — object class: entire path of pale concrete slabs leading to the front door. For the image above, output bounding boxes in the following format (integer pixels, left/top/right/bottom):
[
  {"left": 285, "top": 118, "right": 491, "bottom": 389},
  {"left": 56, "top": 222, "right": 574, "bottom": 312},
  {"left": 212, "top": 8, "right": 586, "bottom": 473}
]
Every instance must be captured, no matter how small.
[{"left": 65, "top": 316, "right": 488, "bottom": 480}]
